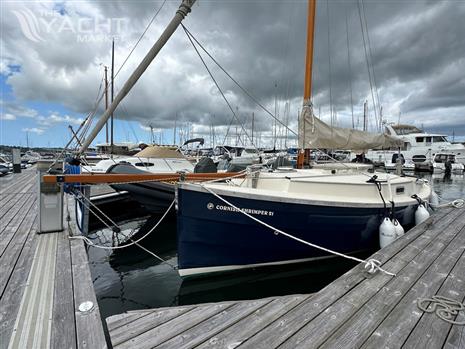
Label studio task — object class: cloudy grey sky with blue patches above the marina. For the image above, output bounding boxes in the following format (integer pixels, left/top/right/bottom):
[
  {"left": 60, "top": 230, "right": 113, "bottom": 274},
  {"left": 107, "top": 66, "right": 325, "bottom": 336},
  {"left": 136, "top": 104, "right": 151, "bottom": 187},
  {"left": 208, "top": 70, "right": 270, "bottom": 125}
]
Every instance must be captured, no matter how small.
[{"left": 0, "top": 0, "right": 465, "bottom": 146}]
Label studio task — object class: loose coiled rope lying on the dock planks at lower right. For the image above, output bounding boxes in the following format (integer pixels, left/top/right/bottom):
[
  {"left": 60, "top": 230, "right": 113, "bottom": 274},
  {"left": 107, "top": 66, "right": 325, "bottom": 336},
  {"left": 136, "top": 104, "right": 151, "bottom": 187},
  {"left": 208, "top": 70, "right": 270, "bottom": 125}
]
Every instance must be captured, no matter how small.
[{"left": 417, "top": 296, "right": 465, "bottom": 326}]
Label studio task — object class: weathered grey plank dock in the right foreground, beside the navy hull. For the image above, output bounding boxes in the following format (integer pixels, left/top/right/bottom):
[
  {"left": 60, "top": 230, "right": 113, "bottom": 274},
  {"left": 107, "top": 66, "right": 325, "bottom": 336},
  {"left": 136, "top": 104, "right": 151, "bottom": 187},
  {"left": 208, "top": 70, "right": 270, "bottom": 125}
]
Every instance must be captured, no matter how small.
[{"left": 106, "top": 208, "right": 465, "bottom": 349}]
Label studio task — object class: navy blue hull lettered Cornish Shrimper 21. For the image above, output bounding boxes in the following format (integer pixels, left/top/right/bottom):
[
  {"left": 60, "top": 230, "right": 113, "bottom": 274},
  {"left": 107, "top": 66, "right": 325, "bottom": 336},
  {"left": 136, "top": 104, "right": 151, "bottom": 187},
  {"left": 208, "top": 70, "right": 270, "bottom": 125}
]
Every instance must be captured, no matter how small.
[{"left": 177, "top": 187, "right": 416, "bottom": 276}]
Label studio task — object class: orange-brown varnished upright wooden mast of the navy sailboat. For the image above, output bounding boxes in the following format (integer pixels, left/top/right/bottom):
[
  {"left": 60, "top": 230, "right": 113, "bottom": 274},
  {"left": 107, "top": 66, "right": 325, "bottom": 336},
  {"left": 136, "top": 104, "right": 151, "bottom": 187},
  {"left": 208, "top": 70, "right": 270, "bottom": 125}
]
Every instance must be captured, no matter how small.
[{"left": 297, "top": 0, "right": 316, "bottom": 168}]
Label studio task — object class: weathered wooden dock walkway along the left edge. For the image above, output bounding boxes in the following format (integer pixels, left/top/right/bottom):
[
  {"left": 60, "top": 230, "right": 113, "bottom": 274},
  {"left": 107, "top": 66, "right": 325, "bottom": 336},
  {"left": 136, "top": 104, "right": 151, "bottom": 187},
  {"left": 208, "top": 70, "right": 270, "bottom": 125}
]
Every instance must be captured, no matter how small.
[{"left": 0, "top": 167, "right": 106, "bottom": 348}]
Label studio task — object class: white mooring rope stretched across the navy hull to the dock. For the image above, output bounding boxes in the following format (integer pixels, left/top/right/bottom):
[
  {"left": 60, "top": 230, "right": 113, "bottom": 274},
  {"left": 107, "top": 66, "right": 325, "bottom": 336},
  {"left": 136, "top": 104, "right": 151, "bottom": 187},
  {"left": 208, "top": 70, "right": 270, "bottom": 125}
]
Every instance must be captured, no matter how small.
[{"left": 199, "top": 183, "right": 396, "bottom": 276}]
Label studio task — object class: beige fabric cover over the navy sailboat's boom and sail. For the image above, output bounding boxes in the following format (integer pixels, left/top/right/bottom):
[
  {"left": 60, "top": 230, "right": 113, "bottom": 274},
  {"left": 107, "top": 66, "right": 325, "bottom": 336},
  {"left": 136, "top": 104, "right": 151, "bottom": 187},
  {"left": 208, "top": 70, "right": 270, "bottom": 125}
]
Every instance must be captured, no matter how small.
[{"left": 299, "top": 107, "right": 404, "bottom": 150}]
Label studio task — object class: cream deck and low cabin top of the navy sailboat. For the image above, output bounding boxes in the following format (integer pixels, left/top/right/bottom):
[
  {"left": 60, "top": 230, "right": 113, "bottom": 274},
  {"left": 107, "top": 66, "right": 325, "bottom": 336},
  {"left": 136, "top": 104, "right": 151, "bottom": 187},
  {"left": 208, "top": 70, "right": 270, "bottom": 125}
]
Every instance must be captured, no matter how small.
[{"left": 180, "top": 169, "right": 430, "bottom": 208}]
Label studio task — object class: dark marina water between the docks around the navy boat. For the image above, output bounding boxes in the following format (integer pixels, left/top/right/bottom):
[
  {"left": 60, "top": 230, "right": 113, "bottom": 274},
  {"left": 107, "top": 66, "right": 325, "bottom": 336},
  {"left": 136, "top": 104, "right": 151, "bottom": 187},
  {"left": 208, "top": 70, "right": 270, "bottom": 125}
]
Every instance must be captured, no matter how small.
[{"left": 85, "top": 173, "right": 465, "bottom": 318}]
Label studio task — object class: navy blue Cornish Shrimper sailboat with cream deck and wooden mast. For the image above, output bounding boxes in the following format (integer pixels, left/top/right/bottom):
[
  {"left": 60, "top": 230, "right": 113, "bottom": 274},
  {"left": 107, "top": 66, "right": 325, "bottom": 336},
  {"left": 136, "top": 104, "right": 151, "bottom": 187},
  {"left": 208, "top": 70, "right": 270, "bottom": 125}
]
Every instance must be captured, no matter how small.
[{"left": 177, "top": 0, "right": 431, "bottom": 276}]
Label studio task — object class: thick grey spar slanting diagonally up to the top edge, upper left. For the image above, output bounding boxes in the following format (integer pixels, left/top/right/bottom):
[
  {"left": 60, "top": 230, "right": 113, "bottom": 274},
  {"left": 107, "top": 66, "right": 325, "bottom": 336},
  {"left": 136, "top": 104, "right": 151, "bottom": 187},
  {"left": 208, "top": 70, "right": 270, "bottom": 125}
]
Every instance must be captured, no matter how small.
[{"left": 78, "top": 0, "right": 195, "bottom": 155}]
